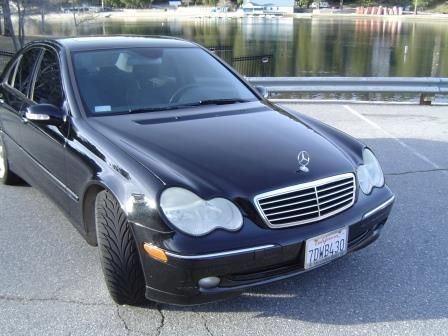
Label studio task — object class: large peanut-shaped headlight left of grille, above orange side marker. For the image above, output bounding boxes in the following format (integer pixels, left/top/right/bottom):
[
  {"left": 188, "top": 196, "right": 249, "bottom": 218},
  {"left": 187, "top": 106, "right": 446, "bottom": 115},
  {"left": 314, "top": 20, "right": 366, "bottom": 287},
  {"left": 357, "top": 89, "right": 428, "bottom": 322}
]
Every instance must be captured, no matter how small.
[{"left": 160, "top": 187, "right": 243, "bottom": 236}]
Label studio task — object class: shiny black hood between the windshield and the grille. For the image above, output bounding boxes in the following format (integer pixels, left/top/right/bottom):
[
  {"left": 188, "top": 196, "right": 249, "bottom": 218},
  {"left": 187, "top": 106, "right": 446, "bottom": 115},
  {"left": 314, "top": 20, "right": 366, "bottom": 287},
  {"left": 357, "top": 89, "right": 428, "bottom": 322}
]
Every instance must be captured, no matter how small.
[{"left": 90, "top": 103, "right": 354, "bottom": 198}]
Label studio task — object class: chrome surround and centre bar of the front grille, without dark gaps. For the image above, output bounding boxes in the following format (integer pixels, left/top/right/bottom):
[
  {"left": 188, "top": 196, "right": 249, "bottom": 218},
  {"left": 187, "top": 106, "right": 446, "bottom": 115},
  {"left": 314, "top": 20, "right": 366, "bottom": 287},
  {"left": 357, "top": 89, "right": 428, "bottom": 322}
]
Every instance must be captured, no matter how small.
[{"left": 253, "top": 173, "right": 356, "bottom": 229}]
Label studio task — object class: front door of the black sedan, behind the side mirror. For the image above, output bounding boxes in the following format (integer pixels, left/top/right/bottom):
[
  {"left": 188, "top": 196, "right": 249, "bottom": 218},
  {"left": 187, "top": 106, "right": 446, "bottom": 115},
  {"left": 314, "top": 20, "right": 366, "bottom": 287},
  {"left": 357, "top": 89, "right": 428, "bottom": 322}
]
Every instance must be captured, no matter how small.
[{"left": 20, "top": 48, "right": 76, "bottom": 209}]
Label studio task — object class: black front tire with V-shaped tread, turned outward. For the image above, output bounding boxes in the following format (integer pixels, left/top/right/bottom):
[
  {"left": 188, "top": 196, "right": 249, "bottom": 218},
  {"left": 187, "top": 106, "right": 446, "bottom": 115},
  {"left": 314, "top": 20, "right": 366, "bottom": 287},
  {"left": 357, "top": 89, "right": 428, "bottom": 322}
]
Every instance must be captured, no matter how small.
[{"left": 95, "top": 191, "right": 146, "bottom": 306}]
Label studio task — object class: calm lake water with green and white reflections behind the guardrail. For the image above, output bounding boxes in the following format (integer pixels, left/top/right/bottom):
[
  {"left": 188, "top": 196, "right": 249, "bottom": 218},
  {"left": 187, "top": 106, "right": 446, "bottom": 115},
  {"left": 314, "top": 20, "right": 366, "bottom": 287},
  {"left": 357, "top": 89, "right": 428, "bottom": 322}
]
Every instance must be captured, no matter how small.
[{"left": 27, "top": 18, "right": 448, "bottom": 77}]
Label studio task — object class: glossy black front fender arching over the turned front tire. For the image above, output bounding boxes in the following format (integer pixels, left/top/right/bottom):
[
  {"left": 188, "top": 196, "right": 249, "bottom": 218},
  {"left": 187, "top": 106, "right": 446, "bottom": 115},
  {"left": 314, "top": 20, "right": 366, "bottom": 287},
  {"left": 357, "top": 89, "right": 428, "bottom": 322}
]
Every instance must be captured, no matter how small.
[{"left": 68, "top": 122, "right": 172, "bottom": 246}]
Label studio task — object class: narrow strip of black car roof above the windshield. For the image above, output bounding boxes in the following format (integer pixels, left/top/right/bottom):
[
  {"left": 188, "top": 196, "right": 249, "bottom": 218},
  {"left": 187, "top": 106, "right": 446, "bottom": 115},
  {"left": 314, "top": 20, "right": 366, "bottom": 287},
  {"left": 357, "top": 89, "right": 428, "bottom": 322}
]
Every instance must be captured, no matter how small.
[{"left": 53, "top": 36, "right": 197, "bottom": 51}]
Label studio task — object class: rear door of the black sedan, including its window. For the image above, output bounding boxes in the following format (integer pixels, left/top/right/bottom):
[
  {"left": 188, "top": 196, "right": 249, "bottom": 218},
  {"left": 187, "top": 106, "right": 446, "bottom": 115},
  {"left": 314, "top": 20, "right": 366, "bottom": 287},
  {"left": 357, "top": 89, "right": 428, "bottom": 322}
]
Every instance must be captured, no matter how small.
[{"left": 0, "top": 48, "right": 42, "bottom": 171}]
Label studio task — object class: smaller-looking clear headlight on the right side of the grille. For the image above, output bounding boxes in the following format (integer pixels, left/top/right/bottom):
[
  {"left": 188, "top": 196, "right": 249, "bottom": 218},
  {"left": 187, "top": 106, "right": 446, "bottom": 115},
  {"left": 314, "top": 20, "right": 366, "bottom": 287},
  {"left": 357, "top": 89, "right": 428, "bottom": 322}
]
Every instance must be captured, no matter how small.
[{"left": 357, "top": 148, "right": 384, "bottom": 194}]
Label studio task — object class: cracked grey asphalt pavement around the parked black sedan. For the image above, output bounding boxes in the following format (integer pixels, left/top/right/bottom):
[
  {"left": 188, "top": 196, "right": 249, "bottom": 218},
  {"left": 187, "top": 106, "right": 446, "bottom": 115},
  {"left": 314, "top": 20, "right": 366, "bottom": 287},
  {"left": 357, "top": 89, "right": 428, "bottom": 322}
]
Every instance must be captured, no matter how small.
[{"left": 0, "top": 104, "right": 448, "bottom": 336}]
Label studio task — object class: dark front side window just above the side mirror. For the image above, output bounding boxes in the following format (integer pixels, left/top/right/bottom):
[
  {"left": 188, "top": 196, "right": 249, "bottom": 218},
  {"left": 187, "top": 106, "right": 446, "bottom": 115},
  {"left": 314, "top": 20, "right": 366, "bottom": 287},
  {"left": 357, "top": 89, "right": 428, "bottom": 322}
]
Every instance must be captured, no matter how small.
[{"left": 32, "top": 50, "right": 64, "bottom": 107}]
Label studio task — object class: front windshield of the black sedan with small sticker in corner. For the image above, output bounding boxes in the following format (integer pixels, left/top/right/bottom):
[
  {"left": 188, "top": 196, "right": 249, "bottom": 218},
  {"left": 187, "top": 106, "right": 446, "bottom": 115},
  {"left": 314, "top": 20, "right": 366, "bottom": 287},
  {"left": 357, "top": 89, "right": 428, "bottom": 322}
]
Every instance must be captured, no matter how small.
[{"left": 73, "top": 47, "right": 258, "bottom": 116}]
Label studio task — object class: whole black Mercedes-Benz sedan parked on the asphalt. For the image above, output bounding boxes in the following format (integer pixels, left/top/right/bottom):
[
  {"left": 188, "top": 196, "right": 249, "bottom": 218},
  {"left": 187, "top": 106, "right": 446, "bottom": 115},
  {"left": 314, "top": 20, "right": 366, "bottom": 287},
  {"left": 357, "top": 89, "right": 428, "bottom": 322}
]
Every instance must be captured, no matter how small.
[{"left": 0, "top": 37, "right": 394, "bottom": 305}]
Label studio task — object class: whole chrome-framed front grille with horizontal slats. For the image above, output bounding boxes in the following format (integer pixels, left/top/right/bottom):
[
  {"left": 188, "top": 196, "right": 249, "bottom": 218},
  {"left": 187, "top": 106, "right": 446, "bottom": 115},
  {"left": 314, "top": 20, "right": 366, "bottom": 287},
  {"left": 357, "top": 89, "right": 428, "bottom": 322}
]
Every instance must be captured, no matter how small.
[{"left": 255, "top": 174, "right": 356, "bottom": 228}]
